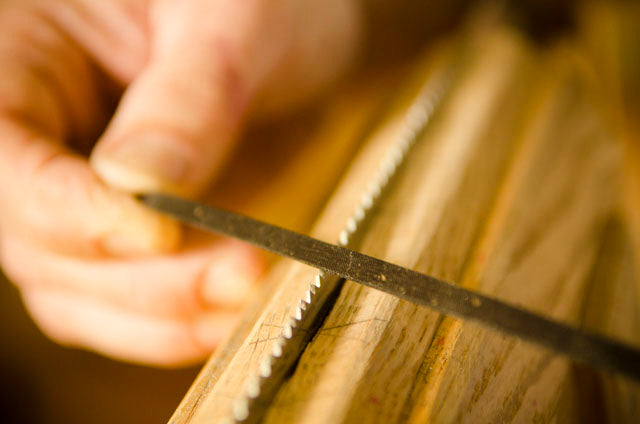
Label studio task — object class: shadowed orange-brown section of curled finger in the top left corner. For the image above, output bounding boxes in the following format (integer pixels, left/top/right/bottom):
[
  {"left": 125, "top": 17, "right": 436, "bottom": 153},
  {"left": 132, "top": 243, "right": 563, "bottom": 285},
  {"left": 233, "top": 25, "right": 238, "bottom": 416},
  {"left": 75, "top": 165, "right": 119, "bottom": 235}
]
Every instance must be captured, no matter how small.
[{"left": 0, "top": 2, "right": 107, "bottom": 152}]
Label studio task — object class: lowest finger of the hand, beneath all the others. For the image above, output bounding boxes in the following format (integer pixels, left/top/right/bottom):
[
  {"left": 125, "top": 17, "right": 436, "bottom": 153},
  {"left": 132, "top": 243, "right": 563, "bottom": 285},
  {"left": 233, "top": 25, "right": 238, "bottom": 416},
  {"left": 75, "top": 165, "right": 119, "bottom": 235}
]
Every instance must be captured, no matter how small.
[{"left": 23, "top": 290, "right": 237, "bottom": 366}]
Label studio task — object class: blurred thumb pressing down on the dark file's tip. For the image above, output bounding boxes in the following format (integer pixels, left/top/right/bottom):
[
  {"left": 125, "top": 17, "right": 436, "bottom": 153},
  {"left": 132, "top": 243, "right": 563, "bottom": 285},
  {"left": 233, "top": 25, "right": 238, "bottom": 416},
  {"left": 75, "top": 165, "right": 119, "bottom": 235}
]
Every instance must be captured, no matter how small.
[{"left": 91, "top": 30, "right": 248, "bottom": 196}]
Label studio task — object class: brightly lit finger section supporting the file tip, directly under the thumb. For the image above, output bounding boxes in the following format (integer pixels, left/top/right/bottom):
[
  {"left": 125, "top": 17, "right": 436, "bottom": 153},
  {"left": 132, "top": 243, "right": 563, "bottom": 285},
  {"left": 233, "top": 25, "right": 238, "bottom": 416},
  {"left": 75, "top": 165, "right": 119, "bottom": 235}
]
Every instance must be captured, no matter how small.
[{"left": 0, "top": 117, "right": 180, "bottom": 255}]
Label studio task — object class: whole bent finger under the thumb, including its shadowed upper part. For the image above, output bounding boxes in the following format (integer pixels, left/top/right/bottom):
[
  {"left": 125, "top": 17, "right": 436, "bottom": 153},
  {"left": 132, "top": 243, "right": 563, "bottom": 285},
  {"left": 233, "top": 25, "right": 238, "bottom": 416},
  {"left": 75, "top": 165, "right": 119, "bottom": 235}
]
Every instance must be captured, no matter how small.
[{"left": 0, "top": 9, "right": 179, "bottom": 254}]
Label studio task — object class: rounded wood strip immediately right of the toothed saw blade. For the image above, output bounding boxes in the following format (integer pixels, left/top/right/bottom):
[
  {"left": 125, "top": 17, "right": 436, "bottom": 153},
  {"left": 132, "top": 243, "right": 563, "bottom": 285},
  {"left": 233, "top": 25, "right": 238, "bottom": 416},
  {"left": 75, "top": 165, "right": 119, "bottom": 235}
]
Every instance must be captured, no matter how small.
[{"left": 267, "top": 29, "right": 544, "bottom": 422}]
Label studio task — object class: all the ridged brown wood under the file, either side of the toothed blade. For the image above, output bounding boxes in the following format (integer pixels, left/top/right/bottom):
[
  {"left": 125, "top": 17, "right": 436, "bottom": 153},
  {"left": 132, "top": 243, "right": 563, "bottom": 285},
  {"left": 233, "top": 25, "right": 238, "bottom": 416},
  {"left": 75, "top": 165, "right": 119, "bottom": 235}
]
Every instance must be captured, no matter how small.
[{"left": 172, "top": 21, "right": 632, "bottom": 423}]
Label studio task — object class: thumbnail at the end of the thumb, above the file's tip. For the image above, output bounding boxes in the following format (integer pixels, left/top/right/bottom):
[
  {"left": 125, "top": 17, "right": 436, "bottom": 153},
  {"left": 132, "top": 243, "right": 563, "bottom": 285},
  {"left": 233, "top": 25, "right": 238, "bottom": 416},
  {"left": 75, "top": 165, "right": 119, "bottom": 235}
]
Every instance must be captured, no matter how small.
[{"left": 91, "top": 134, "right": 194, "bottom": 193}]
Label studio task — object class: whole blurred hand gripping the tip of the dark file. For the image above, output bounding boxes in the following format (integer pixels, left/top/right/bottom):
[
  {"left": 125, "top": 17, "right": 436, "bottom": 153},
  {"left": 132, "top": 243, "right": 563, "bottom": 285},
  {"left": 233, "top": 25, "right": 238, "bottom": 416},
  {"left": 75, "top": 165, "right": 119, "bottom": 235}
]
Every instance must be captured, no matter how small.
[{"left": 0, "top": 0, "right": 360, "bottom": 366}]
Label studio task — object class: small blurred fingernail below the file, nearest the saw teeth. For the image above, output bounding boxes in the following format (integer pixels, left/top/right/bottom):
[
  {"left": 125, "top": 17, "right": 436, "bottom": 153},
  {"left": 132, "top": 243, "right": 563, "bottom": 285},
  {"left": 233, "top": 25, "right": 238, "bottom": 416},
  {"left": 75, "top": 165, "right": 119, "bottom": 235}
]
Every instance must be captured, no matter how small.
[{"left": 203, "top": 261, "right": 256, "bottom": 306}]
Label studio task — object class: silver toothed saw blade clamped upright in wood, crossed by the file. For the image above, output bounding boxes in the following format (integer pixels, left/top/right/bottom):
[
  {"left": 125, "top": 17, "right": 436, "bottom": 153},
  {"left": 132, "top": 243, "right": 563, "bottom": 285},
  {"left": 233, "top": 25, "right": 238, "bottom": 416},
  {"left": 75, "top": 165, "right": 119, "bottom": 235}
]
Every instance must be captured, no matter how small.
[{"left": 141, "top": 60, "right": 457, "bottom": 423}]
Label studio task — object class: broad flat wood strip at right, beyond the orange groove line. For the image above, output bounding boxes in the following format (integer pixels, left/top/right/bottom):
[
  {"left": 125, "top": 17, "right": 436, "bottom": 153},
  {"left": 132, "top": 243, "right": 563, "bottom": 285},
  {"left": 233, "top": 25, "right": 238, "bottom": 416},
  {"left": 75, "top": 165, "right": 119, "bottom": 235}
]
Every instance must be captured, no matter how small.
[{"left": 412, "top": 48, "right": 620, "bottom": 422}]
